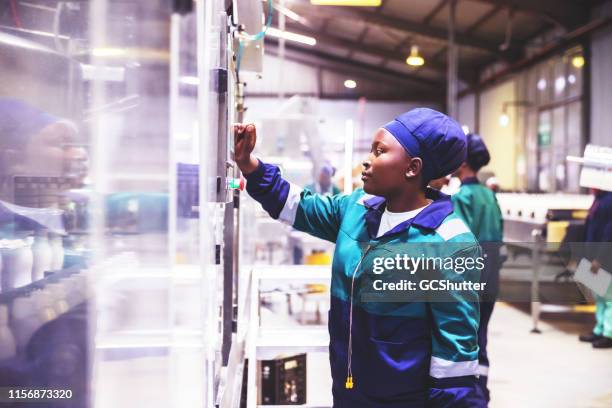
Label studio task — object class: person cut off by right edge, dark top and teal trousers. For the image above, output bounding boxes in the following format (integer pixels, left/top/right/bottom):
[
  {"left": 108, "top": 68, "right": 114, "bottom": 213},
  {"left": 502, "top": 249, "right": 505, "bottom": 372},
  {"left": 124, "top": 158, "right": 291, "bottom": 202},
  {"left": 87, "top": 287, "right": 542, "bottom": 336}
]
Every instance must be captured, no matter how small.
[{"left": 580, "top": 190, "right": 612, "bottom": 348}]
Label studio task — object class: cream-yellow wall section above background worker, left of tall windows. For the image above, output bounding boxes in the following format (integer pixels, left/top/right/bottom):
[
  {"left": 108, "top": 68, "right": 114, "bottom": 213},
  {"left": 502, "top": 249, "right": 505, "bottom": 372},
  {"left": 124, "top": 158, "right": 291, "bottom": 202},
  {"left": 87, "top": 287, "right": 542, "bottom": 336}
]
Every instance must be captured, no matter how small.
[{"left": 479, "top": 80, "right": 517, "bottom": 189}]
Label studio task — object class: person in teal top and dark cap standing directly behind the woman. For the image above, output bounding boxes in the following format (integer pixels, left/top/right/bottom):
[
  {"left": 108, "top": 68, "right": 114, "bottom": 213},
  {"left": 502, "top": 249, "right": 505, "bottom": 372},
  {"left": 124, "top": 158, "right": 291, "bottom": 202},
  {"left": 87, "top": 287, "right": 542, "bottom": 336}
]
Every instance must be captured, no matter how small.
[{"left": 452, "top": 134, "right": 503, "bottom": 401}]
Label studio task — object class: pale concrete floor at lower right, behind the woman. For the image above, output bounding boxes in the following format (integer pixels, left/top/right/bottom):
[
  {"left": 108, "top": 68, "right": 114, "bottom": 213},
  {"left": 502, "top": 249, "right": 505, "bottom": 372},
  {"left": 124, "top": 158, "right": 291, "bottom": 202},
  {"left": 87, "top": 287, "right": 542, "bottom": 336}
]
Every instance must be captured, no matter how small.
[{"left": 489, "top": 303, "right": 612, "bottom": 408}]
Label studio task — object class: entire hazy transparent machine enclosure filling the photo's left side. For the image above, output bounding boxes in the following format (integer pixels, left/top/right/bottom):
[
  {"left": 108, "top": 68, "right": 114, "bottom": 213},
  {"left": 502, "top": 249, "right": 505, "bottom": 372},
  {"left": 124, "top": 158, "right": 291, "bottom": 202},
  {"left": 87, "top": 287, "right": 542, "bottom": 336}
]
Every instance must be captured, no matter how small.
[{"left": 0, "top": 0, "right": 226, "bottom": 407}]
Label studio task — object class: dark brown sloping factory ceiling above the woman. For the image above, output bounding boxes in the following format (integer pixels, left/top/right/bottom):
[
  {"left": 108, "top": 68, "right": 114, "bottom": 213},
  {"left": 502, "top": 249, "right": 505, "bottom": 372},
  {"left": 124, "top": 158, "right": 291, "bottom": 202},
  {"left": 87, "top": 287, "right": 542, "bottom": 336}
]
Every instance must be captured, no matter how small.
[{"left": 266, "top": 0, "right": 600, "bottom": 101}]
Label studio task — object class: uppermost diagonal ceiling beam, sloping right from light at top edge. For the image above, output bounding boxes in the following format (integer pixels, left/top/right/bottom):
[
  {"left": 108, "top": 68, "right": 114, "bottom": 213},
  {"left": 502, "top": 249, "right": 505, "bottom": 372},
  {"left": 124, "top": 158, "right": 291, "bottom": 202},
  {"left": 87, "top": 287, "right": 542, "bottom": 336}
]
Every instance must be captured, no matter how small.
[{"left": 292, "top": 3, "right": 520, "bottom": 59}]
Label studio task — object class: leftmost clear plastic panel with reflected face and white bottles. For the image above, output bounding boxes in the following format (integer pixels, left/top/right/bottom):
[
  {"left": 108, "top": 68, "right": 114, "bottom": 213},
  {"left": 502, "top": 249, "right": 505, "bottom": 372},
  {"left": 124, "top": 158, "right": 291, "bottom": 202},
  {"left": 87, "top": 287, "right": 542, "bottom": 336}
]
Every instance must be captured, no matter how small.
[{"left": 0, "top": 1, "right": 91, "bottom": 407}]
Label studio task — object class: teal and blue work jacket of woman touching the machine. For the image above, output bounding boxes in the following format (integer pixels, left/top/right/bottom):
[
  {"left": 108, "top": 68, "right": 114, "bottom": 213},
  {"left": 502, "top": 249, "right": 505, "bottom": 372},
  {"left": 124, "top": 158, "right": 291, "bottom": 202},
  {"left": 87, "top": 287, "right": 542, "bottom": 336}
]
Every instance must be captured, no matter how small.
[{"left": 246, "top": 162, "right": 486, "bottom": 408}]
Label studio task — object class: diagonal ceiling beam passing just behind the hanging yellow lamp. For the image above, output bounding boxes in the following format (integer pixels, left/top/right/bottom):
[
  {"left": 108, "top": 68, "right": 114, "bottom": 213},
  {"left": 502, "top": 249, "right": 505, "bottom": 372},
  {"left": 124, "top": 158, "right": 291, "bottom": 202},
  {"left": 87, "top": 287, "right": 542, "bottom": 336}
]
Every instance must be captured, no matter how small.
[{"left": 287, "top": 24, "right": 474, "bottom": 82}]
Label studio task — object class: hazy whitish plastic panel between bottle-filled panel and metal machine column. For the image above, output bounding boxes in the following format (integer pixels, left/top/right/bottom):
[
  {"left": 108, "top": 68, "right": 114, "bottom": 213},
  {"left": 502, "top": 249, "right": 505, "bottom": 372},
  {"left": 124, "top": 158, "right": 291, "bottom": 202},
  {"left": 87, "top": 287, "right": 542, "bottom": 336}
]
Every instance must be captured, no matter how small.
[{"left": 89, "top": 1, "right": 181, "bottom": 407}]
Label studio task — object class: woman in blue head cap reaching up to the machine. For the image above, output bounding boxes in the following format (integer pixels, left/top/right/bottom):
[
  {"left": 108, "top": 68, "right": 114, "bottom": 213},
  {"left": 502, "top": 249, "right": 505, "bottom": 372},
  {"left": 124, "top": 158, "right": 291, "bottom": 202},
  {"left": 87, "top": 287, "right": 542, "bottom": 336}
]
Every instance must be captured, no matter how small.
[{"left": 235, "top": 109, "right": 486, "bottom": 408}]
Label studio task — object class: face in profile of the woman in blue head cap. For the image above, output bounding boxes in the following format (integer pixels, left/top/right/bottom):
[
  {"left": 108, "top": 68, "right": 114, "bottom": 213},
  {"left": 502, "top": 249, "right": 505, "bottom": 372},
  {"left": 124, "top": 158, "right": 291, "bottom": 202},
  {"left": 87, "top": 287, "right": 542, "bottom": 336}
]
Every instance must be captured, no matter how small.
[{"left": 361, "top": 128, "right": 411, "bottom": 197}]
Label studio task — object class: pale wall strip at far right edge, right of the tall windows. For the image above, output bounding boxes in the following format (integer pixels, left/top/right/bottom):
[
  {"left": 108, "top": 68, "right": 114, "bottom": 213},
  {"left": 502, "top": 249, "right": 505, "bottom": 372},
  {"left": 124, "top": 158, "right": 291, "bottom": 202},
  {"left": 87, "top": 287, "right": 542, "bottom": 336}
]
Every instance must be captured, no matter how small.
[{"left": 591, "top": 1, "right": 612, "bottom": 146}]
